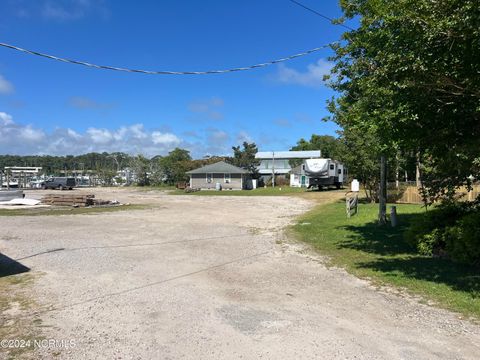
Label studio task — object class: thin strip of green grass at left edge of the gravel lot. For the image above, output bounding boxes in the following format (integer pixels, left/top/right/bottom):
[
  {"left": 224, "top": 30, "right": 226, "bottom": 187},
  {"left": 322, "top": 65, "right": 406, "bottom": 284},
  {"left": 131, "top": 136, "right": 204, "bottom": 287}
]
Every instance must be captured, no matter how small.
[{"left": 0, "top": 205, "right": 147, "bottom": 216}]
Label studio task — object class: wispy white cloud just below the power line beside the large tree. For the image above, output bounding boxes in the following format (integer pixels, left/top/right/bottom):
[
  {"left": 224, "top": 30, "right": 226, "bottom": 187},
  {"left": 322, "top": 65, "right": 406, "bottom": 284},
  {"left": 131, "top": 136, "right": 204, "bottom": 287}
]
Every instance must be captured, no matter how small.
[{"left": 275, "top": 59, "right": 333, "bottom": 87}]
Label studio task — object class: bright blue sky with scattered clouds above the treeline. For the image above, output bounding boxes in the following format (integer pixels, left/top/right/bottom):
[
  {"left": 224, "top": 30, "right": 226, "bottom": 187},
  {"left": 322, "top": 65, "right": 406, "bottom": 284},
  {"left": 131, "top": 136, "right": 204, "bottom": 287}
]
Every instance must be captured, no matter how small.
[{"left": 0, "top": 0, "right": 352, "bottom": 157}]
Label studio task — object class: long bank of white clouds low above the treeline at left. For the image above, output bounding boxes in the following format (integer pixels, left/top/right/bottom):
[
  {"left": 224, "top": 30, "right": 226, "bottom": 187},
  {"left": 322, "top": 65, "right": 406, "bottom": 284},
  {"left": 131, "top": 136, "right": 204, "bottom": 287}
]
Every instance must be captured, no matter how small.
[{"left": 0, "top": 112, "right": 187, "bottom": 156}]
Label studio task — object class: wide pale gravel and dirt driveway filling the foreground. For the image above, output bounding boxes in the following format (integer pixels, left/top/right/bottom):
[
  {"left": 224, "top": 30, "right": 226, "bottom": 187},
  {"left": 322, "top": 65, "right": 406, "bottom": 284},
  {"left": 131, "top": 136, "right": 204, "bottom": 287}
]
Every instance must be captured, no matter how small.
[{"left": 0, "top": 191, "right": 480, "bottom": 359}]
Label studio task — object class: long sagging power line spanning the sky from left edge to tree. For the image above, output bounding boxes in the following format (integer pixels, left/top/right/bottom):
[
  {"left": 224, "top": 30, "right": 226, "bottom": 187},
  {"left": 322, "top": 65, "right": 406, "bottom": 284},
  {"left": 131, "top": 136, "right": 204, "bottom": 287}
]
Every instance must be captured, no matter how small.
[{"left": 0, "top": 43, "right": 331, "bottom": 75}]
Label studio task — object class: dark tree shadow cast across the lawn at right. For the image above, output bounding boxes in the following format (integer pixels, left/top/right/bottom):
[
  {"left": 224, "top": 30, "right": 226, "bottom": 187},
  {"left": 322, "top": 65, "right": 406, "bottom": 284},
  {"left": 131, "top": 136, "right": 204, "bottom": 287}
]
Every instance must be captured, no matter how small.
[{"left": 337, "top": 214, "right": 480, "bottom": 299}]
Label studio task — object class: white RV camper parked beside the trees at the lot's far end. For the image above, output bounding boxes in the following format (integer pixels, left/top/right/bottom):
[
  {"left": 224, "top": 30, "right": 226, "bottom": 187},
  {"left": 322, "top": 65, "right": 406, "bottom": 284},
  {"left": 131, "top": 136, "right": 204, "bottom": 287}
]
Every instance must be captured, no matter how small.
[{"left": 304, "top": 159, "right": 346, "bottom": 189}]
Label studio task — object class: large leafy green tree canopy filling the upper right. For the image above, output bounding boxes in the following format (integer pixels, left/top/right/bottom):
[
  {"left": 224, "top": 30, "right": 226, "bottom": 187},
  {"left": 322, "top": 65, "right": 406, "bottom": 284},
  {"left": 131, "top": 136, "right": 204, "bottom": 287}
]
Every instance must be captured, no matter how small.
[{"left": 329, "top": 0, "right": 480, "bottom": 201}]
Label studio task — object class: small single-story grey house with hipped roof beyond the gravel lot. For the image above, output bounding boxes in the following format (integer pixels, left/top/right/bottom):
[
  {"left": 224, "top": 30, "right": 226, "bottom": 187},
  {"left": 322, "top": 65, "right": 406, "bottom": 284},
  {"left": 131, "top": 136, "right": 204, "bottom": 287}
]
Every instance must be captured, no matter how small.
[{"left": 187, "top": 161, "right": 250, "bottom": 190}]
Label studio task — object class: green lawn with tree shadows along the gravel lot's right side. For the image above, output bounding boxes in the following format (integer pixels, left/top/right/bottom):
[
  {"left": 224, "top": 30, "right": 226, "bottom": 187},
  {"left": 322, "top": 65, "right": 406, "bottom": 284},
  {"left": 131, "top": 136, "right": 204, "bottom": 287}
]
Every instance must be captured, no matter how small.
[{"left": 293, "top": 202, "right": 480, "bottom": 321}]
